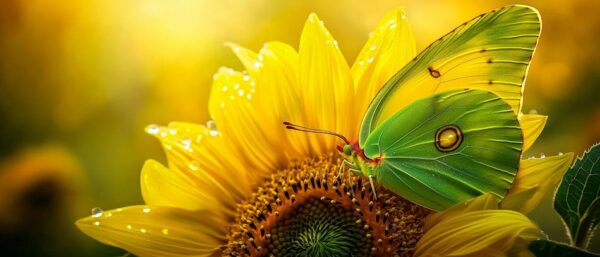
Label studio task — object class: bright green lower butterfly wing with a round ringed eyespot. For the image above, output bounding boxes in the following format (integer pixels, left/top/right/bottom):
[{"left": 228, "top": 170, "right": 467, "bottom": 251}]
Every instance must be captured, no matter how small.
[{"left": 364, "top": 89, "right": 523, "bottom": 211}]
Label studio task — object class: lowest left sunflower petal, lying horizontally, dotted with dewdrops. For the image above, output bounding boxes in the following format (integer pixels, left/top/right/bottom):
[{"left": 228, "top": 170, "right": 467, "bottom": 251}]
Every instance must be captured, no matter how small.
[{"left": 76, "top": 206, "right": 228, "bottom": 256}]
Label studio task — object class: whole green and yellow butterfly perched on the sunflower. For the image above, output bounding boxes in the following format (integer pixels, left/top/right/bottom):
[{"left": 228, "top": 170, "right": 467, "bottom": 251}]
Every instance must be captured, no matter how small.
[{"left": 284, "top": 5, "right": 541, "bottom": 211}]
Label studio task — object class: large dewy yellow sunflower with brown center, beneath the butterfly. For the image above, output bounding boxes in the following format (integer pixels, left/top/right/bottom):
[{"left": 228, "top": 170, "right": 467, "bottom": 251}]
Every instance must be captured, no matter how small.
[{"left": 76, "top": 9, "right": 573, "bottom": 256}]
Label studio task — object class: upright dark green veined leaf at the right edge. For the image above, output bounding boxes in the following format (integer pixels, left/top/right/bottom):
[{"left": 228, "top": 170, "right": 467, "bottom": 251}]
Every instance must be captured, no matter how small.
[{"left": 554, "top": 144, "right": 600, "bottom": 248}]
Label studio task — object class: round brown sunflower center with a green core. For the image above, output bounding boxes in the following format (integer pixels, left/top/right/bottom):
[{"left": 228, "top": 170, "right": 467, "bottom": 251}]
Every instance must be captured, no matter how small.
[{"left": 223, "top": 156, "right": 429, "bottom": 257}]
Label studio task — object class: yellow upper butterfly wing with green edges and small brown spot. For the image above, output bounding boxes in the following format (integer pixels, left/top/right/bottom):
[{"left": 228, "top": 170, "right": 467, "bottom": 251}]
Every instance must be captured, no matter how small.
[{"left": 359, "top": 5, "right": 541, "bottom": 147}]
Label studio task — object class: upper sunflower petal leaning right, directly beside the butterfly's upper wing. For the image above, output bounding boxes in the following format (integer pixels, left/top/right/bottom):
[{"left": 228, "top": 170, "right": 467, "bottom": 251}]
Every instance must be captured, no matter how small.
[{"left": 352, "top": 8, "right": 416, "bottom": 122}]
